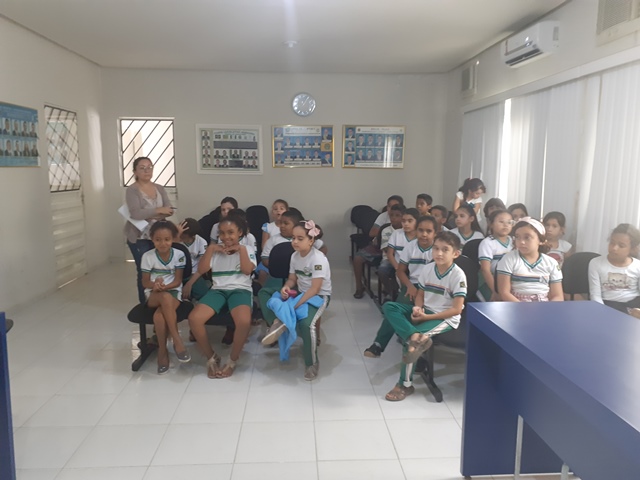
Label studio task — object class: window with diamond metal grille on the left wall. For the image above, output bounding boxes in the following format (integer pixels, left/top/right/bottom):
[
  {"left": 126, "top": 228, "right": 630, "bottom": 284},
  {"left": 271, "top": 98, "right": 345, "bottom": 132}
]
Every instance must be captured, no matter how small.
[{"left": 44, "top": 105, "right": 80, "bottom": 193}]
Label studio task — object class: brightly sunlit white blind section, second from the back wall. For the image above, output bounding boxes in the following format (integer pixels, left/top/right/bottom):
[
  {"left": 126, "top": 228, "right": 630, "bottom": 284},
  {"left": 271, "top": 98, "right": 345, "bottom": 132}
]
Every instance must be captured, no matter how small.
[{"left": 502, "top": 90, "right": 551, "bottom": 217}]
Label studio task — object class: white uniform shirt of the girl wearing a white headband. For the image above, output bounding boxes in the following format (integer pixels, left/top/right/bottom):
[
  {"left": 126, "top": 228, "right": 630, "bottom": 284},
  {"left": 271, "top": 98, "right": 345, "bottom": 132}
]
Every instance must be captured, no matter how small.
[{"left": 497, "top": 250, "right": 562, "bottom": 295}]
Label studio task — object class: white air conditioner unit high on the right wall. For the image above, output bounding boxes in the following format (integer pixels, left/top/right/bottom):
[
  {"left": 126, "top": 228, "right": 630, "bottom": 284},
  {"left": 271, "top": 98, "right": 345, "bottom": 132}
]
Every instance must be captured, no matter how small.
[{"left": 502, "top": 21, "right": 560, "bottom": 67}]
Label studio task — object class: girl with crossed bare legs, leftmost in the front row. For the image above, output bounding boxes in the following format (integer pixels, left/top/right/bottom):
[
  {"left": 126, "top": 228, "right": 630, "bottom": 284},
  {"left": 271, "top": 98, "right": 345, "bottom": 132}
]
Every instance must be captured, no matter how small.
[{"left": 140, "top": 220, "right": 191, "bottom": 375}]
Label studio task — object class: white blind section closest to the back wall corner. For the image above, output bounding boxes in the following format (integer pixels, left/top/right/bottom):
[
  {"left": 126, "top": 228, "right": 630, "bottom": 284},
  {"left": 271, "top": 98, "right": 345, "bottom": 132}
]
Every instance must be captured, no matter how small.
[{"left": 458, "top": 102, "right": 504, "bottom": 201}]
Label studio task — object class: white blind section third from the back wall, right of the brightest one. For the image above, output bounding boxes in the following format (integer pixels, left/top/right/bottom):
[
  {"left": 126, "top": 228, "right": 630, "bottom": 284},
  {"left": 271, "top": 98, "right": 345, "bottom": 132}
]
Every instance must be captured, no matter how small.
[{"left": 542, "top": 76, "right": 600, "bottom": 243}]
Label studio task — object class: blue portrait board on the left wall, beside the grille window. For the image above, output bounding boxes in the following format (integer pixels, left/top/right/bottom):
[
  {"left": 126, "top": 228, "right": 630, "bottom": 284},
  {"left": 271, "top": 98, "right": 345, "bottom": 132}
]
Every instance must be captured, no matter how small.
[{"left": 0, "top": 103, "right": 40, "bottom": 167}]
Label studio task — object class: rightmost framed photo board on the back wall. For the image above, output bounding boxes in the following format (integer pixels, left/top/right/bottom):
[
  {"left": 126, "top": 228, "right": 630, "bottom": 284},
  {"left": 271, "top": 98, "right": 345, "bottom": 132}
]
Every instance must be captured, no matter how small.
[{"left": 342, "top": 125, "right": 406, "bottom": 168}]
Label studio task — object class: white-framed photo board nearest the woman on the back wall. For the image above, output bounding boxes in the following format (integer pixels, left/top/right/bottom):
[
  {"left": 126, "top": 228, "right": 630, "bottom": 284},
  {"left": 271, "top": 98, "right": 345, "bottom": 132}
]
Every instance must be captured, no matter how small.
[{"left": 196, "top": 124, "right": 264, "bottom": 175}]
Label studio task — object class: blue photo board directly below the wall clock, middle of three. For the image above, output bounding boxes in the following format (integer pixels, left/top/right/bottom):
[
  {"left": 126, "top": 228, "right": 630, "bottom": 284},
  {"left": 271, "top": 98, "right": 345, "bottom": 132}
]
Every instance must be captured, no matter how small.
[{"left": 271, "top": 125, "right": 334, "bottom": 168}]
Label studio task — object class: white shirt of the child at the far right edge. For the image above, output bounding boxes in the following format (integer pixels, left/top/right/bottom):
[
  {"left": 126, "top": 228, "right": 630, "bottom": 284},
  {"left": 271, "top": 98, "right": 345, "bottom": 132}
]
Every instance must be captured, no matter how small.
[{"left": 589, "top": 255, "right": 640, "bottom": 303}]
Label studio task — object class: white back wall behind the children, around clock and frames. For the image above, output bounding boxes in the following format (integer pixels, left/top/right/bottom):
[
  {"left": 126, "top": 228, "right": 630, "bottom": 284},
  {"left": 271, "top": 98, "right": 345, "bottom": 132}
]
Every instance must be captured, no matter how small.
[{"left": 102, "top": 69, "right": 446, "bottom": 266}]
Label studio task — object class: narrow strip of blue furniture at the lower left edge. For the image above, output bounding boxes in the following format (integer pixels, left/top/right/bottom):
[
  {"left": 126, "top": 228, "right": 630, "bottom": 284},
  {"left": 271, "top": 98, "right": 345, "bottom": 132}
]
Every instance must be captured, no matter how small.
[{"left": 0, "top": 312, "right": 16, "bottom": 480}]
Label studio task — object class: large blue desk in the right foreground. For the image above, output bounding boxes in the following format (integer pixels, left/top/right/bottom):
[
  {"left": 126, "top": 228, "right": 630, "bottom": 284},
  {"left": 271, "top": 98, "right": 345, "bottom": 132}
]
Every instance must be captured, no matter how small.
[{"left": 461, "top": 302, "right": 640, "bottom": 480}]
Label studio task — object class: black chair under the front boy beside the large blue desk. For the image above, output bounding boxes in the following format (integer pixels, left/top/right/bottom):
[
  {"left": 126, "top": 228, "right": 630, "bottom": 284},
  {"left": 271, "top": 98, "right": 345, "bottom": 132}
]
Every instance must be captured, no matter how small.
[{"left": 416, "top": 255, "right": 480, "bottom": 403}]
